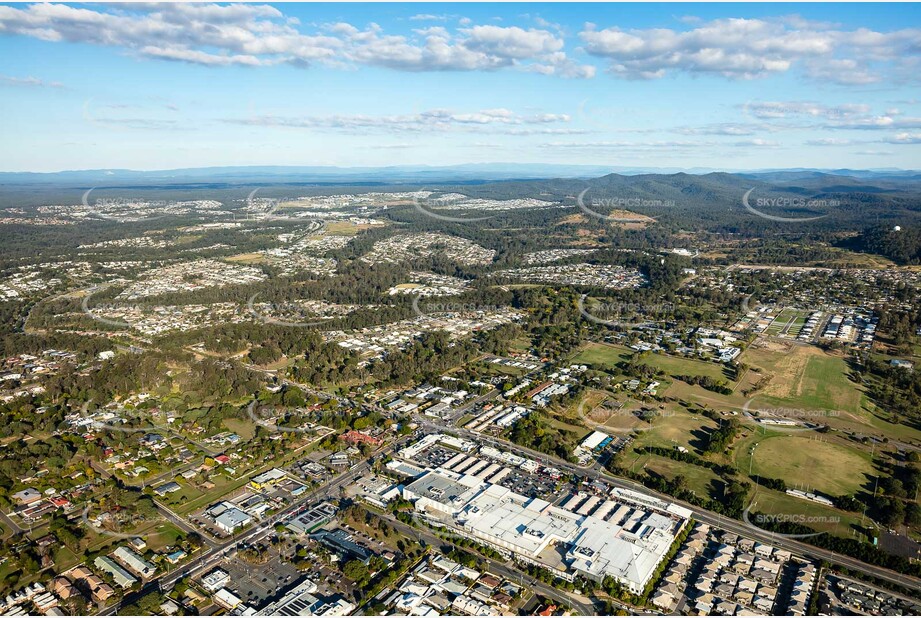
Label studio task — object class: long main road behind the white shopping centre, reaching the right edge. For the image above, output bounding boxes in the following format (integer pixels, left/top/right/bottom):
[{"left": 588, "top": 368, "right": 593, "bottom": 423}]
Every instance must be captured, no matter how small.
[{"left": 417, "top": 418, "right": 921, "bottom": 589}]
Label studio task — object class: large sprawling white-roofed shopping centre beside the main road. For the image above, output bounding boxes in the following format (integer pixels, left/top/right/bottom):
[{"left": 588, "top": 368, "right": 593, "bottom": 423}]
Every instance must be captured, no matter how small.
[{"left": 403, "top": 469, "right": 691, "bottom": 593}]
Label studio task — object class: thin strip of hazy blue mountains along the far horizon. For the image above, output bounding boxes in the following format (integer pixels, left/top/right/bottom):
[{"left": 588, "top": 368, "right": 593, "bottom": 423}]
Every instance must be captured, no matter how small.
[{"left": 0, "top": 163, "right": 921, "bottom": 186}]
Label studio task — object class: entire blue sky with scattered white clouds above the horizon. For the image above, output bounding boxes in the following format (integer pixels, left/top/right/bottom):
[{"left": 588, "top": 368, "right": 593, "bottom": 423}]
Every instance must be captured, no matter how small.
[{"left": 0, "top": 3, "right": 921, "bottom": 171}]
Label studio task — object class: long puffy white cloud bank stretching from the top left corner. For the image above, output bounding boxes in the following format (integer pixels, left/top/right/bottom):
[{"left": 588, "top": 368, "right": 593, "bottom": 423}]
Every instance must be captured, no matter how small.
[{"left": 0, "top": 3, "right": 594, "bottom": 77}]
